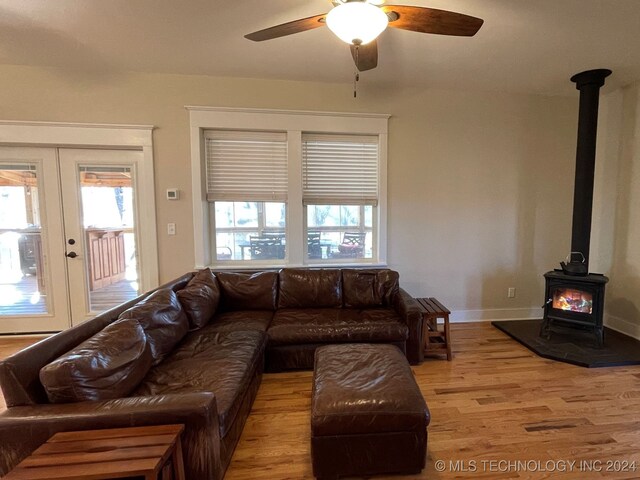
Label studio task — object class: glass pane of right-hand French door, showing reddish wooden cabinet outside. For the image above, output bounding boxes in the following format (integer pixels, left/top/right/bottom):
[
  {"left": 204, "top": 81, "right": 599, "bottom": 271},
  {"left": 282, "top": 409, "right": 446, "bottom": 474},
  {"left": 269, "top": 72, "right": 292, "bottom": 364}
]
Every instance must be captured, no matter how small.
[{"left": 79, "top": 166, "right": 138, "bottom": 312}]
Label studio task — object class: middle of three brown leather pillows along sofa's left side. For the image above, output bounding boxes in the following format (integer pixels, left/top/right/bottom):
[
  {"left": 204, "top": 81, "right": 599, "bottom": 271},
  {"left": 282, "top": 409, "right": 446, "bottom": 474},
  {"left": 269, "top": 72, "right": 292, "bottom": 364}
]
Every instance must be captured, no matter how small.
[{"left": 120, "top": 289, "right": 189, "bottom": 365}]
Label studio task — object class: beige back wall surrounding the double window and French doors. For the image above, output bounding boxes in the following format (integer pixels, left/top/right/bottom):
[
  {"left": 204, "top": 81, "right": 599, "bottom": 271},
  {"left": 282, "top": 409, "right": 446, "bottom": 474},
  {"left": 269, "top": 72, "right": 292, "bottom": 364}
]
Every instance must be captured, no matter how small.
[{"left": 0, "top": 62, "right": 580, "bottom": 320}]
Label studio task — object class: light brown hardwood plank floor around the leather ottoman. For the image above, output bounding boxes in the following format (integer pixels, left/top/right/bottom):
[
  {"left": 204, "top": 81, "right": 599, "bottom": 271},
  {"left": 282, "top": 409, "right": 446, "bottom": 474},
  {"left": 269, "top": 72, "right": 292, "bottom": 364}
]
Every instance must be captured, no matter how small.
[{"left": 0, "top": 323, "right": 640, "bottom": 480}]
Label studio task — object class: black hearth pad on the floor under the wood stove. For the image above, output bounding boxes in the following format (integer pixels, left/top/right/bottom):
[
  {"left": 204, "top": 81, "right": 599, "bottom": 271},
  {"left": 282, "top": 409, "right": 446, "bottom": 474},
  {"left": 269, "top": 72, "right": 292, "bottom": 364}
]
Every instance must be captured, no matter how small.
[{"left": 491, "top": 320, "right": 640, "bottom": 368}]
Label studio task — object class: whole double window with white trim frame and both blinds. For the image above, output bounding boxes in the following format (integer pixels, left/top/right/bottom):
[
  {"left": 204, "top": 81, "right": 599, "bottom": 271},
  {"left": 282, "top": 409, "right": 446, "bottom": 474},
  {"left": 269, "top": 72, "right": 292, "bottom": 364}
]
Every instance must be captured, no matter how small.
[{"left": 187, "top": 107, "right": 388, "bottom": 268}]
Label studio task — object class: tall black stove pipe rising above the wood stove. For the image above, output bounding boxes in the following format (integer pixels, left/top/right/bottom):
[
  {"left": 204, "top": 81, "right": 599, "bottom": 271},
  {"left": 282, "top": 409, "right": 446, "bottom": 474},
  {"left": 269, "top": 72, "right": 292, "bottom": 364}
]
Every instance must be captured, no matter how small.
[{"left": 571, "top": 69, "right": 611, "bottom": 271}]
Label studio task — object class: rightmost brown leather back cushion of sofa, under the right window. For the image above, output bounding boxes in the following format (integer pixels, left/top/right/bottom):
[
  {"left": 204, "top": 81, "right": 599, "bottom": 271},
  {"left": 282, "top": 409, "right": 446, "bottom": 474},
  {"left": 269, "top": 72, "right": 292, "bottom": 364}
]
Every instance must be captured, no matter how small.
[{"left": 342, "top": 268, "right": 400, "bottom": 308}]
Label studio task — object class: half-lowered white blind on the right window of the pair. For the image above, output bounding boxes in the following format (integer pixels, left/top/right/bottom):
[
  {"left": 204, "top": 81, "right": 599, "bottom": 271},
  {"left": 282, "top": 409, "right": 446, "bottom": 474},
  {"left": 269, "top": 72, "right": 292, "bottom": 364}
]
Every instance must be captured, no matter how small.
[{"left": 302, "top": 134, "right": 378, "bottom": 206}]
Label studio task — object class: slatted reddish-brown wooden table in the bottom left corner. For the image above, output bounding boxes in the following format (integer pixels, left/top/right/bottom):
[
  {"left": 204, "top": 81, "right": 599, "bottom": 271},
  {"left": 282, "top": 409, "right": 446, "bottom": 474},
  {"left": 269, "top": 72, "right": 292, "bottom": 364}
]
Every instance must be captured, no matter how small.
[{"left": 3, "top": 425, "right": 185, "bottom": 480}]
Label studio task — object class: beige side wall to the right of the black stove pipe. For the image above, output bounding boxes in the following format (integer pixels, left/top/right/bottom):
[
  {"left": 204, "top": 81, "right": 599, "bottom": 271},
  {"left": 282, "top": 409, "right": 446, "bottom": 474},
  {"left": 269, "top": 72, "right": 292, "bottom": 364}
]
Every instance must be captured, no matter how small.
[{"left": 592, "top": 83, "right": 640, "bottom": 338}]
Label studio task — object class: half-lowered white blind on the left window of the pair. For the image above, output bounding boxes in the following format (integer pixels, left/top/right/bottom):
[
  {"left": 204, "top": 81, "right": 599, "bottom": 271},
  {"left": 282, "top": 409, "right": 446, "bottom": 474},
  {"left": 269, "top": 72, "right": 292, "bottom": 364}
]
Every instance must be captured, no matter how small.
[{"left": 205, "top": 130, "right": 287, "bottom": 202}]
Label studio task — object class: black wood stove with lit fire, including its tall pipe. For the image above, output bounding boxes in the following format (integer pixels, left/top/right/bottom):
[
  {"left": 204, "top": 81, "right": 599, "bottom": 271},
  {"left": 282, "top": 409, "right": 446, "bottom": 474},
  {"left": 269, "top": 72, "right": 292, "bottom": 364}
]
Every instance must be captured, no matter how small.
[{"left": 540, "top": 69, "right": 611, "bottom": 346}]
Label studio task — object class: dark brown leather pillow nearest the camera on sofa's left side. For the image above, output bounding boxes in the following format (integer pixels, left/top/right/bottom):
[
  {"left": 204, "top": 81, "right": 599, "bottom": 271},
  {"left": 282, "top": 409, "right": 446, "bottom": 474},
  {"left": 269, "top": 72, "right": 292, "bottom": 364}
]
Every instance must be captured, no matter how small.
[{"left": 40, "top": 319, "right": 153, "bottom": 403}]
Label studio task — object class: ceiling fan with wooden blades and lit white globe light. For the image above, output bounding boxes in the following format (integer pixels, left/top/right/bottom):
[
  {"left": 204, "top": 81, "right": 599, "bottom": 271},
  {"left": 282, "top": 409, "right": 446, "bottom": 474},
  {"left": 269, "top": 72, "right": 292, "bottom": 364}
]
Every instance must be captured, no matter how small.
[{"left": 245, "top": 0, "right": 484, "bottom": 72}]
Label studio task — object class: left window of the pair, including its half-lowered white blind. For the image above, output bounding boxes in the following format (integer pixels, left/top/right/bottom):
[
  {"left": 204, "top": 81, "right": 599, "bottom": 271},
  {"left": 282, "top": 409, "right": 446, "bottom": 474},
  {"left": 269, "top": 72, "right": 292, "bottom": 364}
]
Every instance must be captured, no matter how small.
[{"left": 205, "top": 130, "right": 287, "bottom": 262}]
